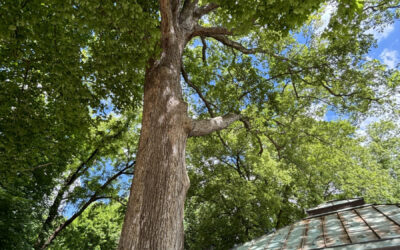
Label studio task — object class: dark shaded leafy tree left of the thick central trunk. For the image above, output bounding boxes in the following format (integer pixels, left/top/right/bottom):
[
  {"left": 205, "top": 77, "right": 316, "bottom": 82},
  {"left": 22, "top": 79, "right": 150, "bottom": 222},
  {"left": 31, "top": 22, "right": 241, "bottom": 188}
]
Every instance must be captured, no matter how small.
[{"left": 0, "top": 1, "right": 149, "bottom": 249}]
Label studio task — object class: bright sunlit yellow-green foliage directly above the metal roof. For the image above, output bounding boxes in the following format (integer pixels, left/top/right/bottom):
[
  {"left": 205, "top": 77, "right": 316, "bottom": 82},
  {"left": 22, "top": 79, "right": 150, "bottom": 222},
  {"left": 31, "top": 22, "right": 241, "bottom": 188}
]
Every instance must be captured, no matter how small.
[{"left": 185, "top": 115, "right": 400, "bottom": 249}]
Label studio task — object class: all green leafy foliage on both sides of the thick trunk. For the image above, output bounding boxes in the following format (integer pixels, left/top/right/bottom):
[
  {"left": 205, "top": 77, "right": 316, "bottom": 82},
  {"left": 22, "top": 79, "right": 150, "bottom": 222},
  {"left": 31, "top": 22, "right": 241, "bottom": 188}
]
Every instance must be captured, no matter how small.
[{"left": 0, "top": 0, "right": 400, "bottom": 249}]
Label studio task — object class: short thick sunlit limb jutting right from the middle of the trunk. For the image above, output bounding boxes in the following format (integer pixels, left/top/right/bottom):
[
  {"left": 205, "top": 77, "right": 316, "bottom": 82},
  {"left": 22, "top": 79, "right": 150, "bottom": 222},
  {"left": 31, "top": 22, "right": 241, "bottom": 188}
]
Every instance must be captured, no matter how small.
[{"left": 189, "top": 114, "right": 242, "bottom": 137}]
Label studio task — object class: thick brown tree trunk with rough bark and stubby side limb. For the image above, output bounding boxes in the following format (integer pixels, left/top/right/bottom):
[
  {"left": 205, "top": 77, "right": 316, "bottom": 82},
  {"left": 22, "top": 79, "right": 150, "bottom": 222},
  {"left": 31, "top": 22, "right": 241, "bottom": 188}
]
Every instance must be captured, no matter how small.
[{"left": 119, "top": 0, "right": 240, "bottom": 250}]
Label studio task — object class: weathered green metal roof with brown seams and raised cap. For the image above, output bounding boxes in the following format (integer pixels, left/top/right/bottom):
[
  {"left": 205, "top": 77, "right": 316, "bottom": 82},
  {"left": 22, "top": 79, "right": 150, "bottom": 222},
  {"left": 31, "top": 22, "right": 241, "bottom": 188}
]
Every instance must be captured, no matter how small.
[{"left": 234, "top": 199, "right": 400, "bottom": 250}]
